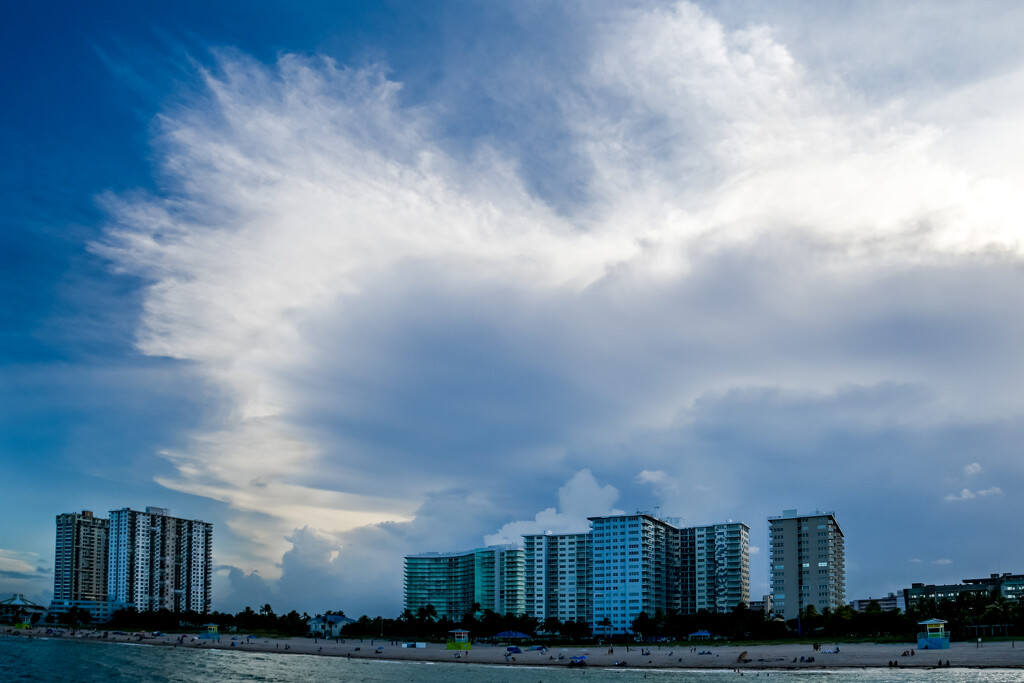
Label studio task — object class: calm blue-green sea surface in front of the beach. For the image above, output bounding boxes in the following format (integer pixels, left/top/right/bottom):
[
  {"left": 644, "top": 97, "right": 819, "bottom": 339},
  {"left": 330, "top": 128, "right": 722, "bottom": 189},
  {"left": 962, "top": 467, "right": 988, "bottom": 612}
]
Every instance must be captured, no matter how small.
[{"left": 0, "top": 636, "right": 1024, "bottom": 683}]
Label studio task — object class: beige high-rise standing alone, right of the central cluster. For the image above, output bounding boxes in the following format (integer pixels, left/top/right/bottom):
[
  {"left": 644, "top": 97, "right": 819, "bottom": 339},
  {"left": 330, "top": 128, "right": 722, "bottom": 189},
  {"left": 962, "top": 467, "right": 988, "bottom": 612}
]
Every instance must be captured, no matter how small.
[{"left": 768, "top": 510, "right": 846, "bottom": 620}]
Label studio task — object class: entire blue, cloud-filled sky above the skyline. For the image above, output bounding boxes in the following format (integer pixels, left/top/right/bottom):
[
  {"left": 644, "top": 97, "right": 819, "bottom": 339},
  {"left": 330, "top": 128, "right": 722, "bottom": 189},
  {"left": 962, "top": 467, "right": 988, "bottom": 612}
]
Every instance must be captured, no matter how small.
[{"left": 0, "top": 0, "right": 1024, "bottom": 616}]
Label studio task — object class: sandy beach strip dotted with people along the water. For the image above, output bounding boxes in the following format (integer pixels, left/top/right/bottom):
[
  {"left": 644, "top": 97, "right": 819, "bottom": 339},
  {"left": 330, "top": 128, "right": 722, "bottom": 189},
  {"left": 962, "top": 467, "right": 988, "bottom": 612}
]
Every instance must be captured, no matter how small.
[{"left": 12, "top": 629, "right": 1024, "bottom": 670}]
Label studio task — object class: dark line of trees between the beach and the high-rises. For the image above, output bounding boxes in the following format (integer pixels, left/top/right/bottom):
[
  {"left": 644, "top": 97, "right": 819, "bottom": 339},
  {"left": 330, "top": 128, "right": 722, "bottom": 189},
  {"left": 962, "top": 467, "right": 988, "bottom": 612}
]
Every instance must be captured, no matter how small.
[{"left": 47, "top": 593, "right": 1024, "bottom": 642}]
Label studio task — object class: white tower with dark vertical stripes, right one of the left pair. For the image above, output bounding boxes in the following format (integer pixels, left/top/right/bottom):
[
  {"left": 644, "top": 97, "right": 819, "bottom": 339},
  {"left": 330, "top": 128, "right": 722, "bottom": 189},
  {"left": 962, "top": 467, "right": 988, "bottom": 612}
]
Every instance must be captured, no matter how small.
[{"left": 106, "top": 507, "right": 213, "bottom": 613}]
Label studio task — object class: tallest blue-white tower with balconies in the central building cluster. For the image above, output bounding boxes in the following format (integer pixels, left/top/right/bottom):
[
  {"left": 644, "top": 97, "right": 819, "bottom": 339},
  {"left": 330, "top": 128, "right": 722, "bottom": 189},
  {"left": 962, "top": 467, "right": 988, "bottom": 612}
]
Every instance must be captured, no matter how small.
[{"left": 590, "top": 513, "right": 682, "bottom": 634}]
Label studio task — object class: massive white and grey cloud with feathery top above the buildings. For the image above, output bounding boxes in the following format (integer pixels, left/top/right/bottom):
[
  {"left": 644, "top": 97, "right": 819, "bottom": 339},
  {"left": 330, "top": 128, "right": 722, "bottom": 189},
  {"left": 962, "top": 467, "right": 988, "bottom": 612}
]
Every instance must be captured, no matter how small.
[{"left": 96, "top": 3, "right": 1024, "bottom": 606}]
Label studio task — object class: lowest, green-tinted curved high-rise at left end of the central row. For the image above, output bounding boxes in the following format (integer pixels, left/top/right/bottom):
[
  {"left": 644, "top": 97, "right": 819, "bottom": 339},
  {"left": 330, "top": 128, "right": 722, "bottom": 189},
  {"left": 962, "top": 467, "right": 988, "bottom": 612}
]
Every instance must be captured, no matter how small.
[{"left": 404, "top": 545, "right": 525, "bottom": 621}]
